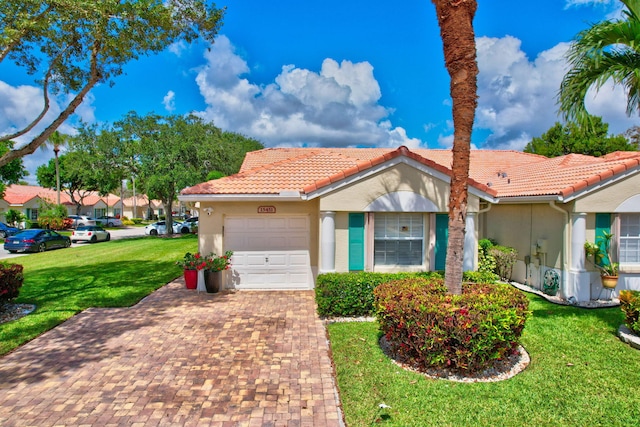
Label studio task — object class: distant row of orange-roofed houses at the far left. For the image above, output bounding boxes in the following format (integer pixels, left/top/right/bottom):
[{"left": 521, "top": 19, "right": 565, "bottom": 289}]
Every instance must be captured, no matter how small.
[{"left": 0, "top": 184, "right": 120, "bottom": 221}]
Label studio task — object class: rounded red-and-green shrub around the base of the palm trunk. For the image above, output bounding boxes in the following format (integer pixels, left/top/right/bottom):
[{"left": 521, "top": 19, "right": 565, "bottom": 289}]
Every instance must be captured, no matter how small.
[{"left": 374, "top": 278, "right": 530, "bottom": 373}]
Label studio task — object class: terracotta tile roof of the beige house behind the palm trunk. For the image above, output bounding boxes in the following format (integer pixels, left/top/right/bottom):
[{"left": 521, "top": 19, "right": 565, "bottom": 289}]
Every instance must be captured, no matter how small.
[{"left": 182, "top": 147, "right": 640, "bottom": 198}]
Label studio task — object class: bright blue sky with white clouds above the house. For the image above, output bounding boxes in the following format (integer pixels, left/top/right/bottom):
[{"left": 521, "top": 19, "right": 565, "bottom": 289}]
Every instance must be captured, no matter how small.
[{"left": 0, "top": 0, "right": 640, "bottom": 179}]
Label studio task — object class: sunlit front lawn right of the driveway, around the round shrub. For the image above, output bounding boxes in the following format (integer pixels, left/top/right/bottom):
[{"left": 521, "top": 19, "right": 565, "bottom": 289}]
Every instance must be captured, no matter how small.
[{"left": 329, "top": 295, "right": 640, "bottom": 427}]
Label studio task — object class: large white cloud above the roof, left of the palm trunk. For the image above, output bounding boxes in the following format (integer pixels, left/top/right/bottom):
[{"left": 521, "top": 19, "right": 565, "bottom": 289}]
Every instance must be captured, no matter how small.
[{"left": 196, "top": 36, "right": 421, "bottom": 147}]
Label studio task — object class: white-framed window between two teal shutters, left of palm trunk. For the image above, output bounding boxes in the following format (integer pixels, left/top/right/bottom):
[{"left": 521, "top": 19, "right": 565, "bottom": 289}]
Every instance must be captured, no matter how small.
[{"left": 373, "top": 213, "right": 424, "bottom": 265}]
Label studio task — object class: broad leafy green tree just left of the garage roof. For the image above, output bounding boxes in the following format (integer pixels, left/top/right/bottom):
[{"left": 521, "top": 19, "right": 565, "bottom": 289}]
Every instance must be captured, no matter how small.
[{"left": 83, "top": 112, "right": 263, "bottom": 233}]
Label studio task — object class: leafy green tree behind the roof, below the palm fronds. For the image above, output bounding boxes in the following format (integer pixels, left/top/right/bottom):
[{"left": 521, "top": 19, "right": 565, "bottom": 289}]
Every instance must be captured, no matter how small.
[{"left": 524, "top": 117, "right": 637, "bottom": 157}]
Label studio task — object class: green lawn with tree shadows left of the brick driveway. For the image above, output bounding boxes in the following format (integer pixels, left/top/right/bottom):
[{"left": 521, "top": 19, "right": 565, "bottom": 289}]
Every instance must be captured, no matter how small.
[{"left": 0, "top": 235, "right": 198, "bottom": 355}]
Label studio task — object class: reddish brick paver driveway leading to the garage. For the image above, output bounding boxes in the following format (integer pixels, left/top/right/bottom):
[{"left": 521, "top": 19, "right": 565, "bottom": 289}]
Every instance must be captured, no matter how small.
[{"left": 0, "top": 281, "right": 342, "bottom": 427}]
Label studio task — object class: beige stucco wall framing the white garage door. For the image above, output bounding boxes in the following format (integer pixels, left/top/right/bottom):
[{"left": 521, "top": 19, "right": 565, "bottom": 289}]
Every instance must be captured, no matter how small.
[{"left": 198, "top": 200, "right": 320, "bottom": 267}]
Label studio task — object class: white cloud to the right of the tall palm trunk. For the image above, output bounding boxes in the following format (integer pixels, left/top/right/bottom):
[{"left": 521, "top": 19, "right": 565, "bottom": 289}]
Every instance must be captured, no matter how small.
[{"left": 476, "top": 36, "right": 637, "bottom": 150}]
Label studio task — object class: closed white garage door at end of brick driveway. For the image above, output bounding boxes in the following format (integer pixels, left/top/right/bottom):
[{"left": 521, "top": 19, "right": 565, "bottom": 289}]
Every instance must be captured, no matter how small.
[{"left": 224, "top": 216, "right": 313, "bottom": 289}]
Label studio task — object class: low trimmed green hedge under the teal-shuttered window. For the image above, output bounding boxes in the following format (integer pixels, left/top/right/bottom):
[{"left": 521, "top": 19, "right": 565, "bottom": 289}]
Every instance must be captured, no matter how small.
[{"left": 315, "top": 271, "right": 498, "bottom": 317}]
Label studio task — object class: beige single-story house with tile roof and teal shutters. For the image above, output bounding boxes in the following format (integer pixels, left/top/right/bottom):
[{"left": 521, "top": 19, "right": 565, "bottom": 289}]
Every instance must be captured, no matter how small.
[{"left": 179, "top": 147, "right": 640, "bottom": 301}]
